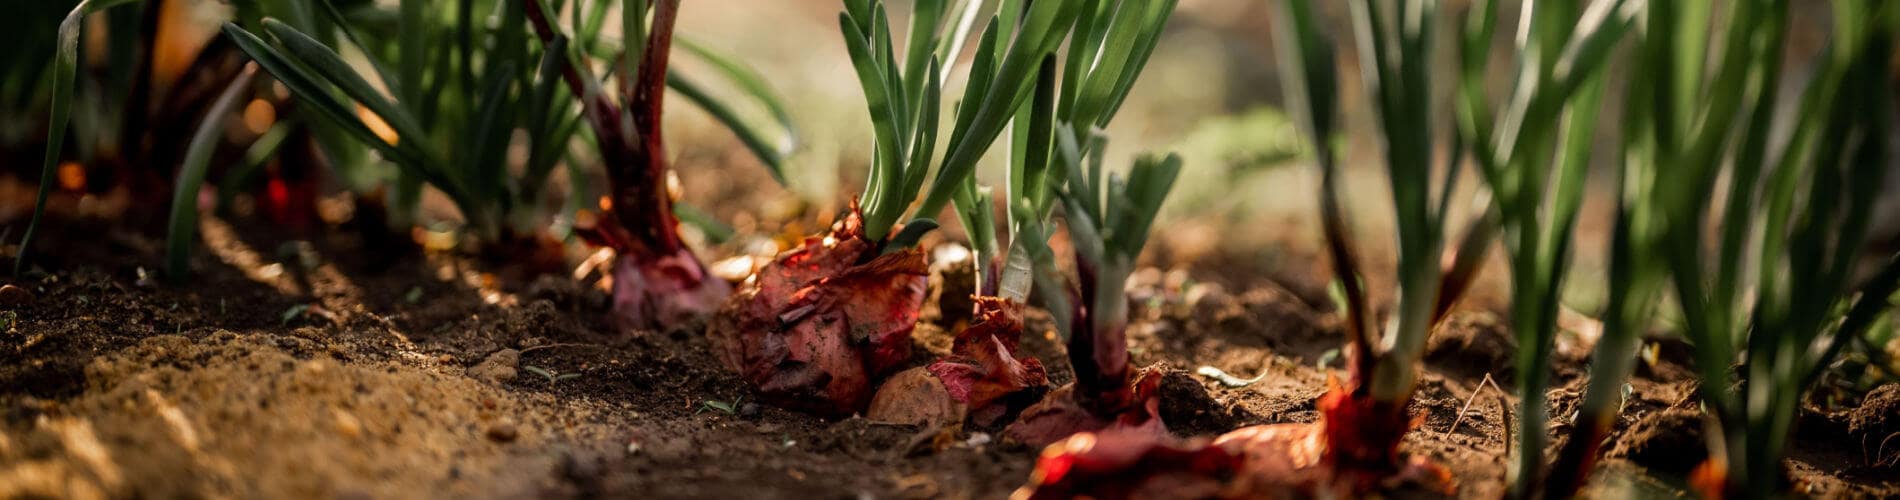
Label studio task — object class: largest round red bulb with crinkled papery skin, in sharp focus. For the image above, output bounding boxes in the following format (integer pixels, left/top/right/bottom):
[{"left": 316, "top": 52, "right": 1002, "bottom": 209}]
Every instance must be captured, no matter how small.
[{"left": 707, "top": 205, "right": 929, "bottom": 416}]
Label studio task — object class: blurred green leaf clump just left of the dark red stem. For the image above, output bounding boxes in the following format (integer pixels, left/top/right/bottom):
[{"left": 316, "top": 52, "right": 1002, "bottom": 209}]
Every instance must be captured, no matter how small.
[{"left": 226, "top": 0, "right": 792, "bottom": 258}]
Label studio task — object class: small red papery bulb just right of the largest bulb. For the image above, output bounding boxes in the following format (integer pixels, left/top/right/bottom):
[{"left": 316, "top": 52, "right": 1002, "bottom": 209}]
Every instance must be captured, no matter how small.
[{"left": 925, "top": 297, "right": 1049, "bottom": 426}]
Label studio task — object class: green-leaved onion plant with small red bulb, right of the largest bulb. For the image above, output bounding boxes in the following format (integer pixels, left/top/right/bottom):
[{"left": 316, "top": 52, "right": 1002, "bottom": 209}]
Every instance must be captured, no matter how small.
[{"left": 870, "top": 0, "right": 1174, "bottom": 426}]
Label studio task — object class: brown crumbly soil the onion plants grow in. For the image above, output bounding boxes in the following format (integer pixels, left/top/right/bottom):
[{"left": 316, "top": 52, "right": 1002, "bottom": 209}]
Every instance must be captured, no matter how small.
[{"left": 0, "top": 210, "right": 1900, "bottom": 498}]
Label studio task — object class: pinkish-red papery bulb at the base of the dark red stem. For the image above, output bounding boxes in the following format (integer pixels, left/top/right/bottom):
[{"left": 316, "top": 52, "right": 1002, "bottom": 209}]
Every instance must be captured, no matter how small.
[{"left": 614, "top": 247, "right": 732, "bottom": 331}]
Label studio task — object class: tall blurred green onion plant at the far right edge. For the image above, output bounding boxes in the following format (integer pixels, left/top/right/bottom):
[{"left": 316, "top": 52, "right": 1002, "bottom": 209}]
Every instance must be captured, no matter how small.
[{"left": 1625, "top": 0, "right": 1900, "bottom": 498}]
